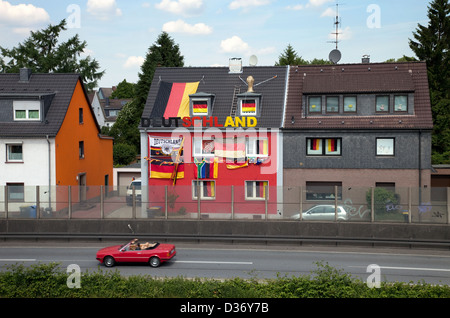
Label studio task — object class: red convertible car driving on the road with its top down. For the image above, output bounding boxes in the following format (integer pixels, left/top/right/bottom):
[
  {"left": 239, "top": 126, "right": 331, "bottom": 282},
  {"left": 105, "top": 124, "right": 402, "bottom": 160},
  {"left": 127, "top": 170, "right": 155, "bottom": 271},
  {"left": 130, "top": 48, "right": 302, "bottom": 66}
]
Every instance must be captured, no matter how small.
[{"left": 96, "top": 239, "right": 177, "bottom": 267}]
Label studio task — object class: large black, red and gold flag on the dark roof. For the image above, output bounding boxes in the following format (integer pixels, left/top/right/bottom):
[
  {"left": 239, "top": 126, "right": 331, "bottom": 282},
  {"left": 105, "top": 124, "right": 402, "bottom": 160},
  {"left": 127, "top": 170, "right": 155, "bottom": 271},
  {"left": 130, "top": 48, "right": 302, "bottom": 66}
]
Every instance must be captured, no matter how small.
[{"left": 150, "top": 82, "right": 200, "bottom": 119}]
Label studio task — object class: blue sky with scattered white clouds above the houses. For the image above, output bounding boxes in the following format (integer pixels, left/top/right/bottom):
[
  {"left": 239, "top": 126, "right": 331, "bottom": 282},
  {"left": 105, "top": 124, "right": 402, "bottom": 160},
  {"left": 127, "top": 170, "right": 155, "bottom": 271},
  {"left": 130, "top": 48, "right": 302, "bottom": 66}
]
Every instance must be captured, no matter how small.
[{"left": 0, "top": 0, "right": 431, "bottom": 87}]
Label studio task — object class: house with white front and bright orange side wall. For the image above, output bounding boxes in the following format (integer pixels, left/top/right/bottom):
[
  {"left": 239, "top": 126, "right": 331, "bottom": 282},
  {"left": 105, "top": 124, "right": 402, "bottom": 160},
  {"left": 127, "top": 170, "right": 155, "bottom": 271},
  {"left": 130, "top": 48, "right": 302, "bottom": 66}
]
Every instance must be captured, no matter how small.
[{"left": 0, "top": 68, "right": 113, "bottom": 212}]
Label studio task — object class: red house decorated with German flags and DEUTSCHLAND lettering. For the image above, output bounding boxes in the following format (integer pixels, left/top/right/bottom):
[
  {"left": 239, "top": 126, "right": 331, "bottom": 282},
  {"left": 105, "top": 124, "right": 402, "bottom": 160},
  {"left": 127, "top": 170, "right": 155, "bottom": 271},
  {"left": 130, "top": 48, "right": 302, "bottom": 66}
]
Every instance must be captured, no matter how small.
[{"left": 140, "top": 67, "right": 289, "bottom": 218}]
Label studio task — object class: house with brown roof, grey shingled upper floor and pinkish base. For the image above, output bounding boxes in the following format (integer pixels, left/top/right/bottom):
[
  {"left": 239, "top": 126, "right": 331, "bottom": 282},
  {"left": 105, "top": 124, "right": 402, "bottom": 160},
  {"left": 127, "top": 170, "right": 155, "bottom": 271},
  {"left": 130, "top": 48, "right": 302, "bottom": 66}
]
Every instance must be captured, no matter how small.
[{"left": 283, "top": 62, "right": 433, "bottom": 216}]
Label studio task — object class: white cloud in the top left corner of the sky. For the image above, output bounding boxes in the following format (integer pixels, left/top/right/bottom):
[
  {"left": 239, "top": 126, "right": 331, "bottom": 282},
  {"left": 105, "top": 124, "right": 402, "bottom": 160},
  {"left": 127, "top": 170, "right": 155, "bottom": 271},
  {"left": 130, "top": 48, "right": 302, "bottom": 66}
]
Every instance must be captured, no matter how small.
[{"left": 0, "top": 0, "right": 50, "bottom": 26}]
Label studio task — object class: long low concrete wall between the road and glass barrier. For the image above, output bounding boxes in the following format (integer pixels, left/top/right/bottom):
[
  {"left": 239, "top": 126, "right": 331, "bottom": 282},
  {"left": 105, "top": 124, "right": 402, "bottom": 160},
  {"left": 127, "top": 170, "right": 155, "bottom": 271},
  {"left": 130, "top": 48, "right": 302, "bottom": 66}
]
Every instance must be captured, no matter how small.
[{"left": 0, "top": 219, "right": 450, "bottom": 246}]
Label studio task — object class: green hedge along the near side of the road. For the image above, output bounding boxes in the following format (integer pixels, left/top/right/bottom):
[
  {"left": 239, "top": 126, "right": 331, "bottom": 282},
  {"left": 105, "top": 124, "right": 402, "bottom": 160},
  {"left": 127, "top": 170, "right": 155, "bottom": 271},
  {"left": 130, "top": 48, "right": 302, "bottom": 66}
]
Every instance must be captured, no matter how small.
[{"left": 0, "top": 263, "right": 450, "bottom": 298}]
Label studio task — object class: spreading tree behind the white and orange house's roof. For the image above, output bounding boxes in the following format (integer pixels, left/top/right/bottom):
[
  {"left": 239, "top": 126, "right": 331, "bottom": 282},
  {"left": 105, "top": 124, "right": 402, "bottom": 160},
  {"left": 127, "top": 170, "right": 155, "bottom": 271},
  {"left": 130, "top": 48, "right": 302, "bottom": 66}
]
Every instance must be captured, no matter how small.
[{"left": 0, "top": 20, "right": 105, "bottom": 90}]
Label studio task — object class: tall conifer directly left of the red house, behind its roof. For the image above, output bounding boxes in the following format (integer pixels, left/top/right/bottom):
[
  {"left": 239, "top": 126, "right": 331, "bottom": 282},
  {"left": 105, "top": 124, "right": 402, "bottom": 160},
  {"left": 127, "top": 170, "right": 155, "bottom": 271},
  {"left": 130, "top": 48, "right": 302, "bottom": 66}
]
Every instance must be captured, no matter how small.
[{"left": 110, "top": 32, "right": 184, "bottom": 152}]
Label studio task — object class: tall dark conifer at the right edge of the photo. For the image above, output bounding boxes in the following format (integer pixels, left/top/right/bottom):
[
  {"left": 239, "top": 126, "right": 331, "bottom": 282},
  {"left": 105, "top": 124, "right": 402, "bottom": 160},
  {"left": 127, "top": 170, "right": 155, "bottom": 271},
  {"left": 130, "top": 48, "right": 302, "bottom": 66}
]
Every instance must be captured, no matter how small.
[{"left": 409, "top": 0, "right": 450, "bottom": 164}]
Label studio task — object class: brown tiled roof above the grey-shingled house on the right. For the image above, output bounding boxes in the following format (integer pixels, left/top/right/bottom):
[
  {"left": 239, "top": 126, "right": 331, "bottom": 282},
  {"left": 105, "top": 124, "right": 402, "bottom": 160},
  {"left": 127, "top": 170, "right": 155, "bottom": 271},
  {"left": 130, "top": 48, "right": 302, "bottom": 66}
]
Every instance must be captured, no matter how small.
[{"left": 284, "top": 62, "right": 433, "bottom": 129}]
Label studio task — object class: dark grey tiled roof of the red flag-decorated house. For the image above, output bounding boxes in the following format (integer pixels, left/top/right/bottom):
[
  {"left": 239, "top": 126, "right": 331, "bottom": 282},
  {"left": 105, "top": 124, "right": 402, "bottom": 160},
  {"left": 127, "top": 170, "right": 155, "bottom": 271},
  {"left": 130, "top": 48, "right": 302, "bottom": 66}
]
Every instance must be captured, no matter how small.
[{"left": 142, "top": 66, "right": 288, "bottom": 128}]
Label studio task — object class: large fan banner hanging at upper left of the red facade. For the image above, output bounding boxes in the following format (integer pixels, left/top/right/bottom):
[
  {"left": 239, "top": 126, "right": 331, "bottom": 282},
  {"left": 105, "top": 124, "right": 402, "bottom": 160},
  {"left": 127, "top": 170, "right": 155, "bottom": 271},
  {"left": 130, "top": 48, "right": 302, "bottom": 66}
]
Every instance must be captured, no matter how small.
[{"left": 146, "top": 136, "right": 184, "bottom": 182}]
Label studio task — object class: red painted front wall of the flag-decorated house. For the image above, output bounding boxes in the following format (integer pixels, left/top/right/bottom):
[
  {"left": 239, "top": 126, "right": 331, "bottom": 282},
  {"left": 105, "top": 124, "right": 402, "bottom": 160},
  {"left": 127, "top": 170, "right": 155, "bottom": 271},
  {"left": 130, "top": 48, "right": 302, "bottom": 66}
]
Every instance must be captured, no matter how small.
[{"left": 147, "top": 132, "right": 277, "bottom": 214}]
